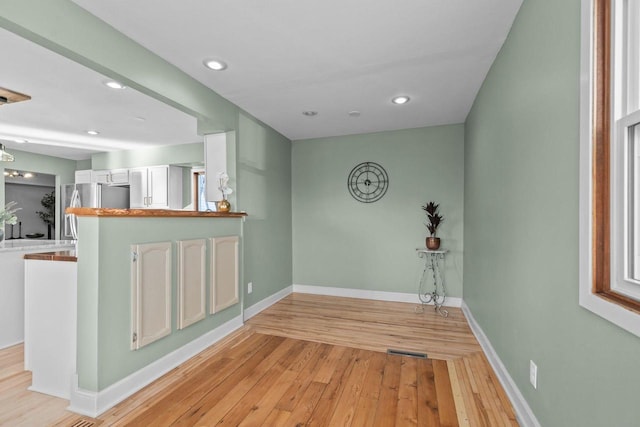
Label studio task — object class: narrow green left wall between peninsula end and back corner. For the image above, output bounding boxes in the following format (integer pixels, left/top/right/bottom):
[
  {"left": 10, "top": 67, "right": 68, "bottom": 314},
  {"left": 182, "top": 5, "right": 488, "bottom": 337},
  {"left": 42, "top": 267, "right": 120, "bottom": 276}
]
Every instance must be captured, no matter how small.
[{"left": 236, "top": 114, "right": 292, "bottom": 307}]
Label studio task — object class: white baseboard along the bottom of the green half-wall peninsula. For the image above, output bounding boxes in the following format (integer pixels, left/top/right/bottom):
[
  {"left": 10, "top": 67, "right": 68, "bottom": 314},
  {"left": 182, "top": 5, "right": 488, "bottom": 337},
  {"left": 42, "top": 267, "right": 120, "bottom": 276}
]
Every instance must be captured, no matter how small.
[{"left": 67, "top": 316, "right": 243, "bottom": 418}]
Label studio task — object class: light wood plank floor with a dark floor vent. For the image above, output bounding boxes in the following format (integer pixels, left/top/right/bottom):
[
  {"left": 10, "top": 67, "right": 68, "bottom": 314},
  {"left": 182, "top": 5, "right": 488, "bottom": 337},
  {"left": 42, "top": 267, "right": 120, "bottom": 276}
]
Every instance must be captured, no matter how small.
[{"left": 0, "top": 294, "right": 517, "bottom": 427}]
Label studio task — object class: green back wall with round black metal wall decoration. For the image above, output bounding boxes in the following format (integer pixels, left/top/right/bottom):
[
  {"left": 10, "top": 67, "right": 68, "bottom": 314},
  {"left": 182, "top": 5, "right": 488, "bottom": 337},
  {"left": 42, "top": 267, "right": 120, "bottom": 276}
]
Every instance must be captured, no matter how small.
[{"left": 292, "top": 125, "right": 464, "bottom": 297}]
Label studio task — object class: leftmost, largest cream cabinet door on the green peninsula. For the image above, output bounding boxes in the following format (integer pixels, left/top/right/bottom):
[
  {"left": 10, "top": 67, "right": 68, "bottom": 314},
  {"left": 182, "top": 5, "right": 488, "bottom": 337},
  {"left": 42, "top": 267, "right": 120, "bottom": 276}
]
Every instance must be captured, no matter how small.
[{"left": 131, "top": 242, "right": 171, "bottom": 350}]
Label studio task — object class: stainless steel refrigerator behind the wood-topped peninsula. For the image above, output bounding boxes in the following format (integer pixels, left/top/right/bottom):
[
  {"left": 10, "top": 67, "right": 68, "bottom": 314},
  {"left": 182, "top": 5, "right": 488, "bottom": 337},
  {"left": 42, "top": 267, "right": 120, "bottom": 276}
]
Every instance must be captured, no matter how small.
[{"left": 60, "top": 183, "right": 129, "bottom": 240}]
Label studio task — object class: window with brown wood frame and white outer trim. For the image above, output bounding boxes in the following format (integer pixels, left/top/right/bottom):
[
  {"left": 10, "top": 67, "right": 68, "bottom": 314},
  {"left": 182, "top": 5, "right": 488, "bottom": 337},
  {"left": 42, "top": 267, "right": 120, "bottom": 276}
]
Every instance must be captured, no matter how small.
[{"left": 580, "top": 0, "right": 640, "bottom": 336}]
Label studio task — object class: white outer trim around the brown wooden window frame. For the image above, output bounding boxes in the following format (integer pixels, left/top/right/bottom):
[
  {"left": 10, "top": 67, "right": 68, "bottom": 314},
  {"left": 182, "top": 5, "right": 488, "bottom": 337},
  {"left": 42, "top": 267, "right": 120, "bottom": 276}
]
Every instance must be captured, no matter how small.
[{"left": 578, "top": 0, "right": 640, "bottom": 337}]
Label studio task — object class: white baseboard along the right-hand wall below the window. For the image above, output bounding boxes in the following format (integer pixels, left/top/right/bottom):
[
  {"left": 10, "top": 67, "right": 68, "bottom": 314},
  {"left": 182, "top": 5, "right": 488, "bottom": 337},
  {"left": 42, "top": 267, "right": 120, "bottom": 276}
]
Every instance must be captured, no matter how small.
[{"left": 462, "top": 302, "right": 540, "bottom": 427}]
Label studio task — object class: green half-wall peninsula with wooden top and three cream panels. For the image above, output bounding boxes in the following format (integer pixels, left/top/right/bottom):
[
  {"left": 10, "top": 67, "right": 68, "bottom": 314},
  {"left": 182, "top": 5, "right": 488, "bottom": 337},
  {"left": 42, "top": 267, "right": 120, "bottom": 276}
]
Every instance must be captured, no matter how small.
[{"left": 61, "top": 208, "right": 247, "bottom": 416}]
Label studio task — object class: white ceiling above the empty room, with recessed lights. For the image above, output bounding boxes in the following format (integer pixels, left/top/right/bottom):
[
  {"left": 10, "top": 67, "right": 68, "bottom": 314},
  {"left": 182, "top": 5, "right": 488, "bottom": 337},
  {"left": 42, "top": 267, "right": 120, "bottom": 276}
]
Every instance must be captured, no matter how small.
[{"left": 74, "top": 0, "right": 522, "bottom": 139}]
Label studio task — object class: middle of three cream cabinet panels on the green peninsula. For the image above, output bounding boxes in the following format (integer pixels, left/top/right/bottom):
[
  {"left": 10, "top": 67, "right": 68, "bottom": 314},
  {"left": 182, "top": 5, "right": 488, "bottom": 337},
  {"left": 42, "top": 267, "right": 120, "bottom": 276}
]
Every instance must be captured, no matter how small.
[{"left": 178, "top": 239, "right": 207, "bottom": 329}]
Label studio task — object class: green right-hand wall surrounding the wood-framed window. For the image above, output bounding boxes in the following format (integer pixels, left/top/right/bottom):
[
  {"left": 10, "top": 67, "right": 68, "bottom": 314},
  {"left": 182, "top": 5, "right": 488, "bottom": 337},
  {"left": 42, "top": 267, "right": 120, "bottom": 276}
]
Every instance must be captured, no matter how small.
[{"left": 464, "top": 0, "right": 640, "bottom": 427}]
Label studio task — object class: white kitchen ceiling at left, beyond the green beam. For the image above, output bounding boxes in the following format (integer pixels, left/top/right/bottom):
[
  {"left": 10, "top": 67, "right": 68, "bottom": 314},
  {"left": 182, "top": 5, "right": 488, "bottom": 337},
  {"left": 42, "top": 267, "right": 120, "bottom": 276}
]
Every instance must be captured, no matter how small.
[{"left": 0, "top": 29, "right": 202, "bottom": 160}]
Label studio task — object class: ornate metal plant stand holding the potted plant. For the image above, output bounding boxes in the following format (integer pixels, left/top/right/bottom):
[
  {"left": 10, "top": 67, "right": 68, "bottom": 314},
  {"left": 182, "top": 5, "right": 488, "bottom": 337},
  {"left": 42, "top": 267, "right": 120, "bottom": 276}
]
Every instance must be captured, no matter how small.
[{"left": 416, "top": 248, "right": 449, "bottom": 317}]
